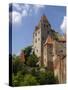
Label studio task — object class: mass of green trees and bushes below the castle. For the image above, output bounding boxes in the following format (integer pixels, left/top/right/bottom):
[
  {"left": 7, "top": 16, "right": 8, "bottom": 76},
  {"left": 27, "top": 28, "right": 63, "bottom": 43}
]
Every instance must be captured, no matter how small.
[{"left": 12, "top": 47, "right": 58, "bottom": 86}]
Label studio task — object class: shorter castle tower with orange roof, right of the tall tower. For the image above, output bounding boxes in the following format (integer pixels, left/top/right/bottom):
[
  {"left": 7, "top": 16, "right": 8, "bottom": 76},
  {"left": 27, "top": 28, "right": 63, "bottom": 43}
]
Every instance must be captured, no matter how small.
[{"left": 43, "top": 35, "right": 53, "bottom": 71}]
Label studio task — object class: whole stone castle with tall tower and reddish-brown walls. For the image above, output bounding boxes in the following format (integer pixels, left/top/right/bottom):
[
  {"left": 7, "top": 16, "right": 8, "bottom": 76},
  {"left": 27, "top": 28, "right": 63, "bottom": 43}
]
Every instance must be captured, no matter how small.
[{"left": 32, "top": 15, "right": 66, "bottom": 83}]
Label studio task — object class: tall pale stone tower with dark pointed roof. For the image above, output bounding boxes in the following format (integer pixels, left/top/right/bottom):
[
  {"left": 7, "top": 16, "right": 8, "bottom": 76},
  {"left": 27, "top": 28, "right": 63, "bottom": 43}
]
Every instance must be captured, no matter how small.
[{"left": 33, "top": 15, "right": 51, "bottom": 65}]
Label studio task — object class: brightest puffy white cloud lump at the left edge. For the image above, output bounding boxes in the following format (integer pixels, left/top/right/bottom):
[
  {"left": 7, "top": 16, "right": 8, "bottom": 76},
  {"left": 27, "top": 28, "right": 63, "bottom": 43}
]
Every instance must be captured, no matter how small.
[{"left": 12, "top": 11, "right": 22, "bottom": 24}]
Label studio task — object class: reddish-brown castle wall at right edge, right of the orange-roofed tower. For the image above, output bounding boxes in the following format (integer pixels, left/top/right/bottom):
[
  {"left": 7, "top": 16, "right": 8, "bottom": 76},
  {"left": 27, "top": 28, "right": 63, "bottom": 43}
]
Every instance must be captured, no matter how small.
[{"left": 53, "top": 41, "right": 66, "bottom": 83}]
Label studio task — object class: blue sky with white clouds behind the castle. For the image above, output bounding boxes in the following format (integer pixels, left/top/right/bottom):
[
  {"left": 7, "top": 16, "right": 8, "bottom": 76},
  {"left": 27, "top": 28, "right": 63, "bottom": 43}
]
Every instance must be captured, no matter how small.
[{"left": 9, "top": 3, "right": 66, "bottom": 55}]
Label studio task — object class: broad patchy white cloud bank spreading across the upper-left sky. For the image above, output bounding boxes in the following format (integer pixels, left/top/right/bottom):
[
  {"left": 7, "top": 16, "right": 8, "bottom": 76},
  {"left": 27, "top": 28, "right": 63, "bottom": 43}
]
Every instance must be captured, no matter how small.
[{"left": 9, "top": 3, "right": 44, "bottom": 24}]
